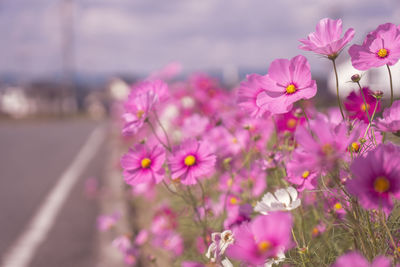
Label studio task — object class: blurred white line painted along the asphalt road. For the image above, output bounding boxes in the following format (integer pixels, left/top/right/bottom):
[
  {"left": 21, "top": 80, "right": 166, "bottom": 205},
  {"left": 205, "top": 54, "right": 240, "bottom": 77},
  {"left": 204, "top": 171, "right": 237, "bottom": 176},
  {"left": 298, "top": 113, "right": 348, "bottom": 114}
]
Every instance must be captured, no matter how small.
[{"left": 0, "top": 126, "right": 105, "bottom": 267}]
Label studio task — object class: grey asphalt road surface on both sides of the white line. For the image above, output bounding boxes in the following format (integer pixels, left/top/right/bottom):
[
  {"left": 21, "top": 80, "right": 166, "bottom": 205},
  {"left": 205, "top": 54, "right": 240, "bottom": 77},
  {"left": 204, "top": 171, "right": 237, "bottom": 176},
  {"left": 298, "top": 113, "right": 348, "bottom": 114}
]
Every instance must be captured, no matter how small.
[{"left": 0, "top": 119, "right": 107, "bottom": 267}]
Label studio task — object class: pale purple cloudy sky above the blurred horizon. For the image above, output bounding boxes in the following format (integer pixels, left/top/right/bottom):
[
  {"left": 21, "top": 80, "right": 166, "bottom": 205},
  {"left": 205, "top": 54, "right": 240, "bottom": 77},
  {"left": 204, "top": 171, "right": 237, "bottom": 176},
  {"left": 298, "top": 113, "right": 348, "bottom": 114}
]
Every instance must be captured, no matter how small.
[{"left": 0, "top": 0, "right": 400, "bottom": 77}]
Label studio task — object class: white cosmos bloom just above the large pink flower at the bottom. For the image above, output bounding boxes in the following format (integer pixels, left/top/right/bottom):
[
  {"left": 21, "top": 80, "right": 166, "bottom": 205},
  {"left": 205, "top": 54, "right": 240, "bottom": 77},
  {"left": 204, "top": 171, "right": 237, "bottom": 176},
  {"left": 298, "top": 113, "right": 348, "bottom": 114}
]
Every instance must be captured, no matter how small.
[{"left": 254, "top": 186, "right": 301, "bottom": 215}]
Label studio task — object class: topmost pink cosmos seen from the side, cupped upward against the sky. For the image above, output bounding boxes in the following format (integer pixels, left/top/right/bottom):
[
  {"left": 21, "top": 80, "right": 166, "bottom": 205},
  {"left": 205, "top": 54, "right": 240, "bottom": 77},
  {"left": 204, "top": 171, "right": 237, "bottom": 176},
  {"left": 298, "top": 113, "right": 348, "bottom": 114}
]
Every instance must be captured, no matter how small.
[{"left": 299, "top": 18, "right": 354, "bottom": 58}]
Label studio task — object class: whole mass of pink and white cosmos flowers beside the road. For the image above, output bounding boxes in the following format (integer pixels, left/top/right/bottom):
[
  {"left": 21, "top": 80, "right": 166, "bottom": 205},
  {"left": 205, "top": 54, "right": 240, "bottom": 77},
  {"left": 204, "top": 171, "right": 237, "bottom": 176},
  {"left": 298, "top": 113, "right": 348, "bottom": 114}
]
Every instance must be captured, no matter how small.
[{"left": 99, "top": 18, "right": 400, "bottom": 267}]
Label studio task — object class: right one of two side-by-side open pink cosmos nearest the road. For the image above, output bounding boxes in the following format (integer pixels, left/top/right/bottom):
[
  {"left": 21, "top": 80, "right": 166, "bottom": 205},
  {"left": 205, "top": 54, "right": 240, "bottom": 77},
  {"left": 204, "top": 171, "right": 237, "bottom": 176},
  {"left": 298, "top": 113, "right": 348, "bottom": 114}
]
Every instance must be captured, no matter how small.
[{"left": 169, "top": 139, "right": 216, "bottom": 185}]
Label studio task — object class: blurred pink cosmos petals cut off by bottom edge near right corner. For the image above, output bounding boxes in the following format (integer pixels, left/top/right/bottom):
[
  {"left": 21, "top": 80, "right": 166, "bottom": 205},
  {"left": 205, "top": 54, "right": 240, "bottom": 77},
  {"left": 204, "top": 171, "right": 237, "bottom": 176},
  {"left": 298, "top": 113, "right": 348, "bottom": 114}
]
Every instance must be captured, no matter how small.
[{"left": 332, "top": 251, "right": 391, "bottom": 267}]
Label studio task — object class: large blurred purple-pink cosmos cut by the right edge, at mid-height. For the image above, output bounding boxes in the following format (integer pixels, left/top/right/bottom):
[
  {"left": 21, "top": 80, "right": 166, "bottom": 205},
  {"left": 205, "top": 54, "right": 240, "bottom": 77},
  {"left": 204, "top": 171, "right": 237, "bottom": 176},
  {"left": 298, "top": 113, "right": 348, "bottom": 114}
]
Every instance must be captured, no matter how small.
[{"left": 347, "top": 143, "right": 400, "bottom": 214}]
